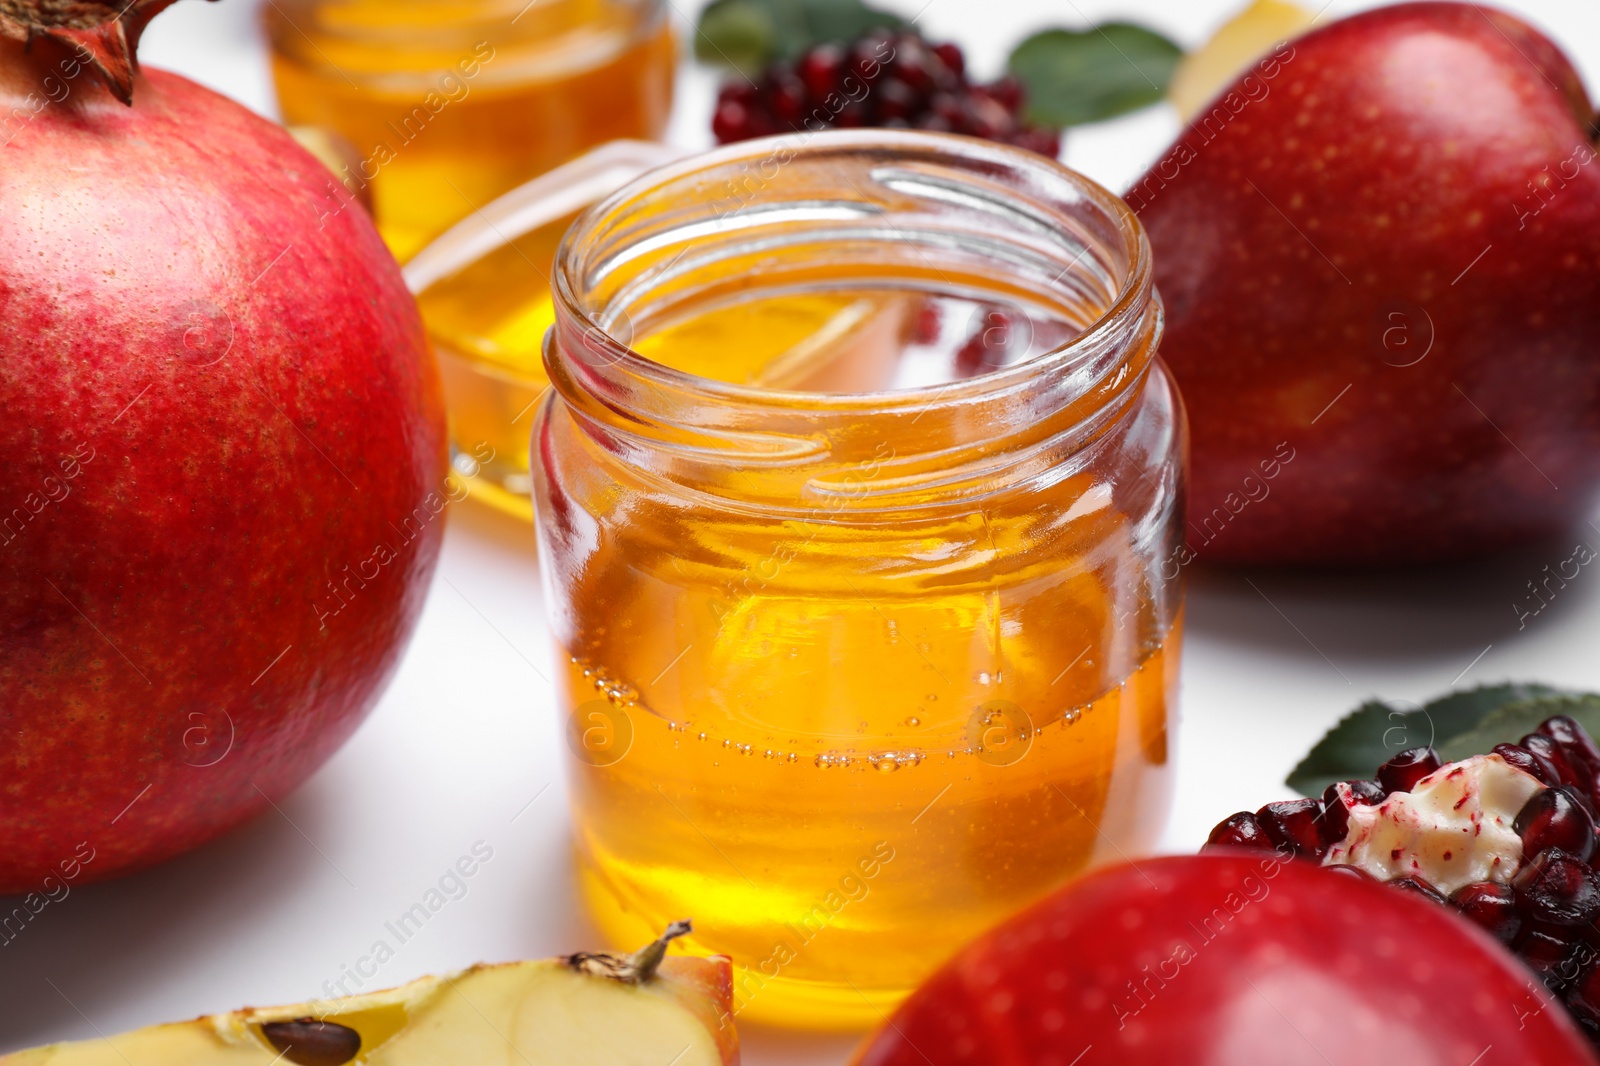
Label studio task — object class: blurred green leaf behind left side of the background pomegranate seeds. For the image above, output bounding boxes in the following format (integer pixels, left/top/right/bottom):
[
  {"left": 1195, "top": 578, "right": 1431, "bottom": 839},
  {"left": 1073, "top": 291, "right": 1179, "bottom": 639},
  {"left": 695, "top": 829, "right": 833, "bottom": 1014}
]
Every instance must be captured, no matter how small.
[{"left": 694, "top": 0, "right": 901, "bottom": 78}]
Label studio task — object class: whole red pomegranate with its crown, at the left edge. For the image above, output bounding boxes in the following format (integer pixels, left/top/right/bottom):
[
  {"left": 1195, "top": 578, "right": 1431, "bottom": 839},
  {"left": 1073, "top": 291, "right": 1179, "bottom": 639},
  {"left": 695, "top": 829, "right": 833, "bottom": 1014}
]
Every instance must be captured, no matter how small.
[{"left": 0, "top": 0, "right": 451, "bottom": 889}]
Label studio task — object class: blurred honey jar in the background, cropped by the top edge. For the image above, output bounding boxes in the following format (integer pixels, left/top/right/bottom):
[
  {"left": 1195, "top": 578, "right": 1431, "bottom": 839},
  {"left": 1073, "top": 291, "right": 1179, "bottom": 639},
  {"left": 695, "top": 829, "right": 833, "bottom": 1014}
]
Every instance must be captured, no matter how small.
[{"left": 264, "top": 0, "right": 675, "bottom": 261}]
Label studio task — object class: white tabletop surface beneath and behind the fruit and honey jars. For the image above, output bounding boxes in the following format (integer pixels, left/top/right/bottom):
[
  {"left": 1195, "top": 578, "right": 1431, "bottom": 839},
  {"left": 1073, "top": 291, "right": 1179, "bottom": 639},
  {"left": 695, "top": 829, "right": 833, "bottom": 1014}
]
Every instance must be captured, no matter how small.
[{"left": 9, "top": 0, "right": 1600, "bottom": 1066}]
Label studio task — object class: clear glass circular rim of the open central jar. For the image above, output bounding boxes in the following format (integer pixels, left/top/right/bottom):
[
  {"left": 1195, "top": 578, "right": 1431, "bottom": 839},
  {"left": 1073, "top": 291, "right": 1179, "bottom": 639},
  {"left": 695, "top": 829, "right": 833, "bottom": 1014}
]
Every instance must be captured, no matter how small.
[{"left": 546, "top": 130, "right": 1155, "bottom": 413}]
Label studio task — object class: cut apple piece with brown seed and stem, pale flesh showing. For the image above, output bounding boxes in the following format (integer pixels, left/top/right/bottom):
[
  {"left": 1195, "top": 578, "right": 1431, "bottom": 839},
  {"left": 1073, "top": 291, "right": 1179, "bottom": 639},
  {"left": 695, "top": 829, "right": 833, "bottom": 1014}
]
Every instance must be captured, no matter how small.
[{"left": 0, "top": 922, "right": 739, "bottom": 1066}]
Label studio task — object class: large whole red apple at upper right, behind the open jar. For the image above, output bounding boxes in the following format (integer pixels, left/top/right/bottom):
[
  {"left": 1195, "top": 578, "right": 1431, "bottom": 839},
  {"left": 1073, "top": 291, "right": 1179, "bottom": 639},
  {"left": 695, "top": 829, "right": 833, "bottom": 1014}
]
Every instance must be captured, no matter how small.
[{"left": 1126, "top": 3, "right": 1600, "bottom": 563}]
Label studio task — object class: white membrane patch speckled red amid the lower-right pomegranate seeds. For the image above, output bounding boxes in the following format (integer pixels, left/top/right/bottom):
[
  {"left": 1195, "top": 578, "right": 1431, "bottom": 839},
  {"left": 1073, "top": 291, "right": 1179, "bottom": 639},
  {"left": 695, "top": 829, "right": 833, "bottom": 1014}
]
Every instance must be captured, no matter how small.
[{"left": 1323, "top": 755, "right": 1546, "bottom": 896}]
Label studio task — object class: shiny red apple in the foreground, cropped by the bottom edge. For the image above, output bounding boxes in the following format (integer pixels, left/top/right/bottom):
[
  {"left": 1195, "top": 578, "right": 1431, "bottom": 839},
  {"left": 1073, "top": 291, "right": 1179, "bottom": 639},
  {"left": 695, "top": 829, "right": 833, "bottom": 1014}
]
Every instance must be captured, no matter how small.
[{"left": 856, "top": 852, "right": 1600, "bottom": 1066}]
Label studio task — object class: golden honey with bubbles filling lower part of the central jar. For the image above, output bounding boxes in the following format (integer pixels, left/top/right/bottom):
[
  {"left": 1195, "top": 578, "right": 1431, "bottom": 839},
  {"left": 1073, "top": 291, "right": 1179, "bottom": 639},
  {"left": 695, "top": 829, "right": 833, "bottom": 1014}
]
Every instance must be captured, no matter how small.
[{"left": 563, "top": 585, "right": 1179, "bottom": 1028}]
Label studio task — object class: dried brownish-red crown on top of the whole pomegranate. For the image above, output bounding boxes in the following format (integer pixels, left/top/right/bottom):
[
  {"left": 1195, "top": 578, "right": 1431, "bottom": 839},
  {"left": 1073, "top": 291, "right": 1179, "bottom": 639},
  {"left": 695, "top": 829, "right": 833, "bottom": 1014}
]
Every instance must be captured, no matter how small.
[{"left": 0, "top": 0, "right": 217, "bottom": 106}]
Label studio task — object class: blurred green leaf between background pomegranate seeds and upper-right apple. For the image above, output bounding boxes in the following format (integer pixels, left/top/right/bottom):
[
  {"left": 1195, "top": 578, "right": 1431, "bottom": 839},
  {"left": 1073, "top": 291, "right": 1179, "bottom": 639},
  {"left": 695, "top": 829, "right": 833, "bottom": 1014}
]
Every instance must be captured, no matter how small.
[{"left": 1006, "top": 22, "right": 1184, "bottom": 128}]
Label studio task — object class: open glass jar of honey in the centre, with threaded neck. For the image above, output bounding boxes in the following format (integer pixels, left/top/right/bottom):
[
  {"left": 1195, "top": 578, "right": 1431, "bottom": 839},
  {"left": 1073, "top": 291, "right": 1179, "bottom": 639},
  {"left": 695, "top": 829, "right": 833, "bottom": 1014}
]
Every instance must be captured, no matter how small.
[{"left": 533, "top": 131, "right": 1186, "bottom": 1028}]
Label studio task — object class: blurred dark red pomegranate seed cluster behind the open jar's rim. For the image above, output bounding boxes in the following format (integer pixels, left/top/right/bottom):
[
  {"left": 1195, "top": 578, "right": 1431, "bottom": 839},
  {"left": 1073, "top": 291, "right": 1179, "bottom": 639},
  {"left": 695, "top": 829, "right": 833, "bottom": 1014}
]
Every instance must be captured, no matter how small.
[{"left": 712, "top": 30, "right": 1061, "bottom": 157}]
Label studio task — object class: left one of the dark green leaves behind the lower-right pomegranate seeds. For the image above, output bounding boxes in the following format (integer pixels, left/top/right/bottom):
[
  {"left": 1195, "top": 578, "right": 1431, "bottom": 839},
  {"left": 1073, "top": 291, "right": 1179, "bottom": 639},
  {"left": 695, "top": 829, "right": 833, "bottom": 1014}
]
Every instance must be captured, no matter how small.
[{"left": 1286, "top": 685, "right": 1562, "bottom": 795}]
